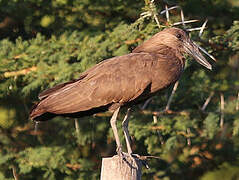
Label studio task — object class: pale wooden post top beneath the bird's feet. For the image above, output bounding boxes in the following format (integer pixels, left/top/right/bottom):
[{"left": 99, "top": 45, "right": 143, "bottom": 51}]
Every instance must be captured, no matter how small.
[{"left": 100, "top": 155, "right": 142, "bottom": 180}]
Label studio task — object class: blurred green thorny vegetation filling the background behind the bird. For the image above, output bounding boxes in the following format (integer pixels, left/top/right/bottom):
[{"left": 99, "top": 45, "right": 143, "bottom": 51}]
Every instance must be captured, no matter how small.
[{"left": 0, "top": 0, "right": 239, "bottom": 180}]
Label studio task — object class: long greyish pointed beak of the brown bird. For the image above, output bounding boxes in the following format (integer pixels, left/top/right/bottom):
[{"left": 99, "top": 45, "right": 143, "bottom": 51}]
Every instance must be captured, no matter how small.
[{"left": 184, "top": 39, "right": 212, "bottom": 70}]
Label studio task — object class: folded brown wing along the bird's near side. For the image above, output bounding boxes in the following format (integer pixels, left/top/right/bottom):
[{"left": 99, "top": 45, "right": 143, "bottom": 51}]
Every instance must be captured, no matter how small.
[{"left": 35, "top": 53, "right": 156, "bottom": 114}]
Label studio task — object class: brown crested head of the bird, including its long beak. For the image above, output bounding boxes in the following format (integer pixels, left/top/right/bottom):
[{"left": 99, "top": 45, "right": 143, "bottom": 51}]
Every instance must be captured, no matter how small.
[{"left": 133, "top": 28, "right": 212, "bottom": 70}]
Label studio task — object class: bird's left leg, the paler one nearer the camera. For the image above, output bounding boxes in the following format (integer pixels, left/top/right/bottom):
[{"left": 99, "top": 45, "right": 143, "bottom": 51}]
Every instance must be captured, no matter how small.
[{"left": 110, "top": 107, "right": 122, "bottom": 156}]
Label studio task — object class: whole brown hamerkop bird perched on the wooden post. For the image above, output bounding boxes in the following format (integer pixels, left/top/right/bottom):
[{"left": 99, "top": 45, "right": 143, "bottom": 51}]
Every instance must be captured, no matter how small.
[{"left": 30, "top": 28, "right": 212, "bottom": 156}]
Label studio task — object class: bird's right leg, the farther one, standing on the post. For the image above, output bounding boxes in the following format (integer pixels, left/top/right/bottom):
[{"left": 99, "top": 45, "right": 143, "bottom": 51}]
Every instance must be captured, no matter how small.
[{"left": 122, "top": 108, "right": 132, "bottom": 155}]
